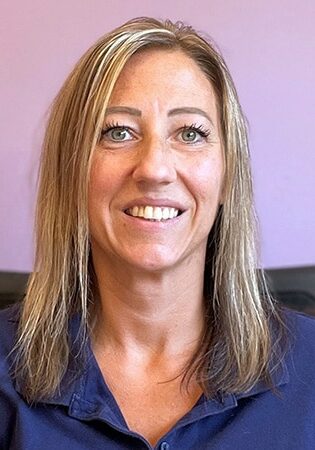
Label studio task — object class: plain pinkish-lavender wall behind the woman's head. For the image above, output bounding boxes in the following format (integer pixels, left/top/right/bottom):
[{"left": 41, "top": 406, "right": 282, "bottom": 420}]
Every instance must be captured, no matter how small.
[{"left": 0, "top": 0, "right": 315, "bottom": 271}]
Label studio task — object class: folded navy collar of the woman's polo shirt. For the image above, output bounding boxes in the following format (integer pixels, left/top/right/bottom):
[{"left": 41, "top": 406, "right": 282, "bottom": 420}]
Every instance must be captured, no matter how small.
[{"left": 9, "top": 308, "right": 289, "bottom": 424}]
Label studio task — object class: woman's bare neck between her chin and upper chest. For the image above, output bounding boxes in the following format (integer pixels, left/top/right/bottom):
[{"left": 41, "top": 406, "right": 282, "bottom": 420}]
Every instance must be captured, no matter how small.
[{"left": 93, "top": 250, "right": 204, "bottom": 361}]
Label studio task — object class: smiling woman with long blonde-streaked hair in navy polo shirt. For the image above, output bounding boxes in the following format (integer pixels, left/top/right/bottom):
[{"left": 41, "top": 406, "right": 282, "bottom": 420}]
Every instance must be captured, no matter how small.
[{"left": 0, "top": 18, "right": 315, "bottom": 449}]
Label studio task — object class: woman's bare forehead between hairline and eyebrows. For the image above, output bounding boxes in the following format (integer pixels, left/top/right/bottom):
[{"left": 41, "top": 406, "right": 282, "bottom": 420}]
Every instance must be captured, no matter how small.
[{"left": 109, "top": 49, "right": 216, "bottom": 120}]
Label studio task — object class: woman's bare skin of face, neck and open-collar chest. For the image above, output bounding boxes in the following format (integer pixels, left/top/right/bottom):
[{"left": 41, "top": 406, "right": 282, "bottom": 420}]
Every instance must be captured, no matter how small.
[{"left": 89, "top": 50, "right": 224, "bottom": 443}]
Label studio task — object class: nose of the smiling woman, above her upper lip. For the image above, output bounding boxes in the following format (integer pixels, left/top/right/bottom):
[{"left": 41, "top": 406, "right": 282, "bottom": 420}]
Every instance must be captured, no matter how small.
[{"left": 133, "top": 138, "right": 177, "bottom": 185}]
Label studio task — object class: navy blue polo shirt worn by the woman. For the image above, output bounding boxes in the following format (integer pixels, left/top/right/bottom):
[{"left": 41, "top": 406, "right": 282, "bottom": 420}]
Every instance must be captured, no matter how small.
[{"left": 0, "top": 308, "right": 315, "bottom": 450}]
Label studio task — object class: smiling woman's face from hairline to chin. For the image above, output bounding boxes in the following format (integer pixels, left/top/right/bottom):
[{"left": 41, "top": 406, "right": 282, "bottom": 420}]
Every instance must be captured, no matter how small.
[{"left": 88, "top": 49, "right": 224, "bottom": 271}]
